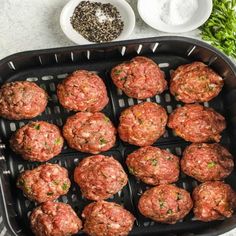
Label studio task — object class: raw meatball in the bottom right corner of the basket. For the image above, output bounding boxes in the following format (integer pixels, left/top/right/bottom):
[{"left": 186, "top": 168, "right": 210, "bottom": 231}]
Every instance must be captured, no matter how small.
[{"left": 193, "top": 181, "right": 236, "bottom": 222}]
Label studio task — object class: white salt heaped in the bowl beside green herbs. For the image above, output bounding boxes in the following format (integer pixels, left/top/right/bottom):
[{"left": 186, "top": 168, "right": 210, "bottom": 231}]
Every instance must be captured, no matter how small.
[{"left": 157, "top": 0, "right": 198, "bottom": 25}]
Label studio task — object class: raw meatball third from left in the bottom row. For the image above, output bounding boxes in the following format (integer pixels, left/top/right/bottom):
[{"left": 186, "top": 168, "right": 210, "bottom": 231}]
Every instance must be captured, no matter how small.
[{"left": 138, "top": 185, "right": 193, "bottom": 224}]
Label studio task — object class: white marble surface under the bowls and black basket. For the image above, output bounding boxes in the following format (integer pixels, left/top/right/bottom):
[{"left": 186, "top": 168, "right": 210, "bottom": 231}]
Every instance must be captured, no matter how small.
[{"left": 0, "top": 0, "right": 236, "bottom": 236}]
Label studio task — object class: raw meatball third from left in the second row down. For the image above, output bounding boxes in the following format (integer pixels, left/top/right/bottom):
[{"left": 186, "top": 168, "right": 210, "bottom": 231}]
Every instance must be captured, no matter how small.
[{"left": 118, "top": 102, "right": 167, "bottom": 146}]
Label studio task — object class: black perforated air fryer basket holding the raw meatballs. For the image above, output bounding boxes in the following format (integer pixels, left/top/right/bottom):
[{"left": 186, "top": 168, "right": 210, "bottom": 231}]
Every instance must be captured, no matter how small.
[{"left": 0, "top": 37, "right": 236, "bottom": 236}]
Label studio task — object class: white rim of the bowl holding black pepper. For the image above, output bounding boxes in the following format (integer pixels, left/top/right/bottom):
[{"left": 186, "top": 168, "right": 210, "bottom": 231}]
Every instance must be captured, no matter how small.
[{"left": 59, "top": 0, "right": 135, "bottom": 45}]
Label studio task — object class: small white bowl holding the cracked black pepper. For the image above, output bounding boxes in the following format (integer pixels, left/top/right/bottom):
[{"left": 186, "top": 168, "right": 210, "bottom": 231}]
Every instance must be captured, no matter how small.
[{"left": 60, "top": 0, "right": 135, "bottom": 44}]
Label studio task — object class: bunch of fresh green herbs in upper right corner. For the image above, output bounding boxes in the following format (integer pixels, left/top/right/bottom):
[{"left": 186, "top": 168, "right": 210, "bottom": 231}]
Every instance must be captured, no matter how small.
[{"left": 200, "top": 0, "right": 236, "bottom": 58}]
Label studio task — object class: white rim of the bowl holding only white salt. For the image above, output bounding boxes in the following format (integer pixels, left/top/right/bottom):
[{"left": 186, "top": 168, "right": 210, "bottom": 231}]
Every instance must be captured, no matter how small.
[{"left": 137, "top": 0, "right": 213, "bottom": 33}]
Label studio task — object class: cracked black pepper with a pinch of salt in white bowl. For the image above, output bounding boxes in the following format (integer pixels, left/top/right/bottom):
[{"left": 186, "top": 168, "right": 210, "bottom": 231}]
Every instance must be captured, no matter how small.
[{"left": 71, "top": 1, "right": 124, "bottom": 43}]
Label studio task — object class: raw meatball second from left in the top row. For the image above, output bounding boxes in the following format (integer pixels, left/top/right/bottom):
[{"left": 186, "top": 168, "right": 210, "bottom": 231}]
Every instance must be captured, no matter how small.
[{"left": 57, "top": 70, "right": 109, "bottom": 112}]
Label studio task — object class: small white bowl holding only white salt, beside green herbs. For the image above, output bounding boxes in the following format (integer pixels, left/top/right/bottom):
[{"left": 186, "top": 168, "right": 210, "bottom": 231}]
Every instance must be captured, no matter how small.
[{"left": 138, "top": 0, "right": 212, "bottom": 33}]
